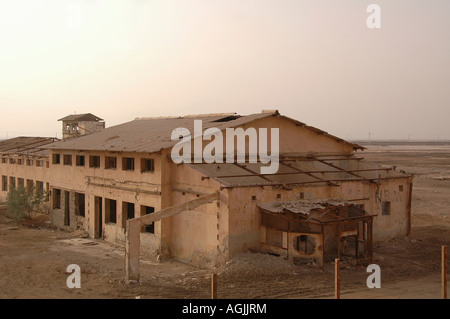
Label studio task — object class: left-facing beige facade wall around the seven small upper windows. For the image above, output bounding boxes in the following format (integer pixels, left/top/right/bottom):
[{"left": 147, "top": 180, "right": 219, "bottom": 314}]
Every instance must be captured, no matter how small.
[{"left": 50, "top": 151, "right": 161, "bottom": 253}]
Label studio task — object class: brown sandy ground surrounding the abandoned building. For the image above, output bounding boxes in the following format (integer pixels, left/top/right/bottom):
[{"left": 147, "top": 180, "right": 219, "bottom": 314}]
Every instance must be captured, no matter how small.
[{"left": 0, "top": 145, "right": 450, "bottom": 299}]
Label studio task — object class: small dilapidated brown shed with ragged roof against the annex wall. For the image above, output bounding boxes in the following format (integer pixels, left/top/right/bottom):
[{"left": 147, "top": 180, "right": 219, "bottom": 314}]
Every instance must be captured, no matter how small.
[{"left": 258, "top": 200, "right": 376, "bottom": 267}]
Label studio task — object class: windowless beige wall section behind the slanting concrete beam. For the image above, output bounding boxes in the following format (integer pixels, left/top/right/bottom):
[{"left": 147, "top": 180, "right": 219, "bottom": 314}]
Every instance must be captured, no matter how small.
[{"left": 170, "top": 160, "right": 228, "bottom": 266}]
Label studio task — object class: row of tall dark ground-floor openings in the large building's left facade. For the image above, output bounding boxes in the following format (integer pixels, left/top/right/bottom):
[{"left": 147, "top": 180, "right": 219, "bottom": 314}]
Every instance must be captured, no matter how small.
[{"left": 53, "top": 188, "right": 155, "bottom": 234}]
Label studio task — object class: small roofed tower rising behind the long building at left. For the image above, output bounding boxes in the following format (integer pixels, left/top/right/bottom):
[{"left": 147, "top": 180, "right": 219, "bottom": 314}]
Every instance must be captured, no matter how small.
[{"left": 58, "top": 113, "right": 105, "bottom": 139}]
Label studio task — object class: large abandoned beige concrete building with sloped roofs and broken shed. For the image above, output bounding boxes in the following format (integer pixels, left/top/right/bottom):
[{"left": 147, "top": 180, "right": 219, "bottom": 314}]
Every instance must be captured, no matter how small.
[{"left": 0, "top": 111, "right": 412, "bottom": 278}]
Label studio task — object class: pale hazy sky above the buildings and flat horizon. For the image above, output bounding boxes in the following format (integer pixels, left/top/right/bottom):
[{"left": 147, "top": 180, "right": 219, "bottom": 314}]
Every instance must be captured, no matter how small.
[{"left": 0, "top": 0, "right": 450, "bottom": 139}]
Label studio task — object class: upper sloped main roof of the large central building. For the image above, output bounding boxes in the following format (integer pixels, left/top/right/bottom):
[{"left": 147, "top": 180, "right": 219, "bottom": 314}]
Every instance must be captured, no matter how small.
[{"left": 44, "top": 111, "right": 362, "bottom": 153}]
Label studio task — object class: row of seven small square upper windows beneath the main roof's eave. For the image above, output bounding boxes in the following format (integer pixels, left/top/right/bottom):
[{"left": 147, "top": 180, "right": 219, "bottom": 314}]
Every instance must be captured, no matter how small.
[{"left": 52, "top": 154, "right": 155, "bottom": 172}]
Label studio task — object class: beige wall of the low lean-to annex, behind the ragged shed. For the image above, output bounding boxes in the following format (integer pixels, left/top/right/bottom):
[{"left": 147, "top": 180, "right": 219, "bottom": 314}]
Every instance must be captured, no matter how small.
[{"left": 229, "top": 177, "right": 410, "bottom": 256}]
